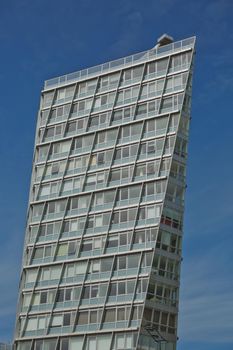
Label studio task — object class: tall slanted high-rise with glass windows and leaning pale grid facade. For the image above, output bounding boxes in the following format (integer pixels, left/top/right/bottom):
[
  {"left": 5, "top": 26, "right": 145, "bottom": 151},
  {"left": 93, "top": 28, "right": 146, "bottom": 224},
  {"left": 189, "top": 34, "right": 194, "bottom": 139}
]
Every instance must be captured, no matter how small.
[{"left": 14, "top": 35, "right": 195, "bottom": 350}]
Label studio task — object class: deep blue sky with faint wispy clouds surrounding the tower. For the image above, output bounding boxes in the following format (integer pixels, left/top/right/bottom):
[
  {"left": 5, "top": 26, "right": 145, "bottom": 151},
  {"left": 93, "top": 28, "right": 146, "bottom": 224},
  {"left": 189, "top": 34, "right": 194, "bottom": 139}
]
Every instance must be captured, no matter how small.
[{"left": 0, "top": 0, "right": 233, "bottom": 350}]
